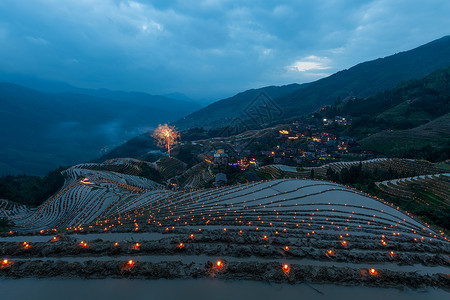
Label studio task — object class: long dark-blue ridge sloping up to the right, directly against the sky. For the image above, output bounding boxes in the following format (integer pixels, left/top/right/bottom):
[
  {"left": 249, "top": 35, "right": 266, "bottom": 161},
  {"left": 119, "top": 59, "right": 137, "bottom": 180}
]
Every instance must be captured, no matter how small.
[{"left": 174, "top": 36, "right": 450, "bottom": 129}]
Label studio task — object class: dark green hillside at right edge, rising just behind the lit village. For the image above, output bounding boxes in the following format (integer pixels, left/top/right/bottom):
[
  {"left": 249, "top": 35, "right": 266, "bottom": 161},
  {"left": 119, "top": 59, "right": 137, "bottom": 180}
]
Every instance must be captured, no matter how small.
[{"left": 316, "top": 67, "right": 450, "bottom": 161}]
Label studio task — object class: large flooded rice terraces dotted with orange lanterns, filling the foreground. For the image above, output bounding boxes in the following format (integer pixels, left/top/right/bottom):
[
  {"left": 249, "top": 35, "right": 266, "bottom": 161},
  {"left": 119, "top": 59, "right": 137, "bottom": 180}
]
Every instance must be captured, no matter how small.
[{"left": 0, "top": 164, "right": 450, "bottom": 288}]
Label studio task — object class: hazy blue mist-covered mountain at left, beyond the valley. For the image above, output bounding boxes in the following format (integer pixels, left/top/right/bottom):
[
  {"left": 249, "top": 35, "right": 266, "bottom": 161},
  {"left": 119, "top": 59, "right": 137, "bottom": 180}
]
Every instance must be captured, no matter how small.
[{"left": 0, "top": 82, "right": 198, "bottom": 176}]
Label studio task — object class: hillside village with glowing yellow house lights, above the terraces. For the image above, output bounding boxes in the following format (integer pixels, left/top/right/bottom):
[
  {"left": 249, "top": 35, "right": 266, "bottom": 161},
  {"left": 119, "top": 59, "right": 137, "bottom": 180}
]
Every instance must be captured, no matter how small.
[{"left": 203, "top": 116, "right": 374, "bottom": 179}]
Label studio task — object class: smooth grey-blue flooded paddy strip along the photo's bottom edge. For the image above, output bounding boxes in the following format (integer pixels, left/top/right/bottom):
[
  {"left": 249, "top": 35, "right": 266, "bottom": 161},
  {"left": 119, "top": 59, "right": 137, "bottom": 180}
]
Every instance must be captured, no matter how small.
[{"left": 0, "top": 279, "right": 449, "bottom": 300}]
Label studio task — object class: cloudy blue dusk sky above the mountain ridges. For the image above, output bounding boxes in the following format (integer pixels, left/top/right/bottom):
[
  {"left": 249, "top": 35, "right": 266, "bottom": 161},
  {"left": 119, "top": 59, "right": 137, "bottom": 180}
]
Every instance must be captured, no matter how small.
[{"left": 0, "top": 0, "right": 450, "bottom": 103}]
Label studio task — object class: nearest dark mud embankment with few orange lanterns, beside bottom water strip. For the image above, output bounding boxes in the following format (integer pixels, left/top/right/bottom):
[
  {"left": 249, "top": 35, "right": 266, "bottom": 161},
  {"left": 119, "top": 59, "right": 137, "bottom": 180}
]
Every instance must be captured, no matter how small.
[{"left": 0, "top": 261, "right": 450, "bottom": 289}]
